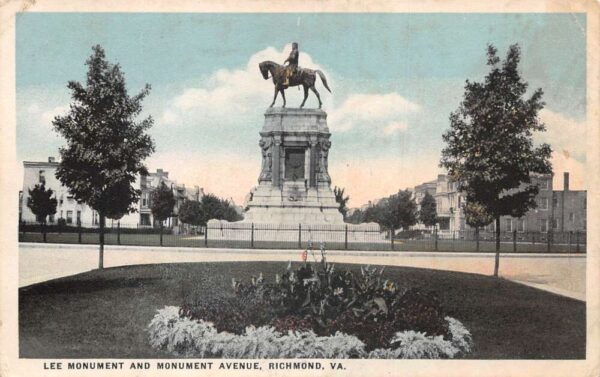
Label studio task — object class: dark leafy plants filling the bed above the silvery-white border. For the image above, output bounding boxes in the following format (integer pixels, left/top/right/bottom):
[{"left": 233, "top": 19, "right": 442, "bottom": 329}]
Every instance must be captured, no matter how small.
[{"left": 180, "top": 250, "right": 462, "bottom": 350}]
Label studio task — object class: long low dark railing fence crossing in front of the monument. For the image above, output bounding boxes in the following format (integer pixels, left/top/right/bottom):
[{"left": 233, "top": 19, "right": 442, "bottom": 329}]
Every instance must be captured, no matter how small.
[{"left": 19, "top": 223, "right": 587, "bottom": 253}]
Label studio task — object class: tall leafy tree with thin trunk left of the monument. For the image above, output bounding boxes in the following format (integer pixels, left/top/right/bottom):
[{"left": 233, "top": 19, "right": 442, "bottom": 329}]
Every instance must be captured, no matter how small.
[{"left": 52, "top": 46, "right": 154, "bottom": 268}]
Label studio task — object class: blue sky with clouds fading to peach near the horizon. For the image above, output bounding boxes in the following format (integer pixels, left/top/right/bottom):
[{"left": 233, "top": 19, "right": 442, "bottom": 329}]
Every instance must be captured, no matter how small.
[{"left": 16, "top": 13, "right": 586, "bottom": 206}]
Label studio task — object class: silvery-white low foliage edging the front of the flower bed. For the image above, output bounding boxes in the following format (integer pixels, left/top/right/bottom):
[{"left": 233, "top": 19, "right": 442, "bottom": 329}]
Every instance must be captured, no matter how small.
[{"left": 148, "top": 306, "right": 472, "bottom": 359}]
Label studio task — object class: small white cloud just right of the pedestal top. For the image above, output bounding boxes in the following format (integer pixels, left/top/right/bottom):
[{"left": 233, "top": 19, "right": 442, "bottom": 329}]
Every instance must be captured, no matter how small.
[{"left": 330, "top": 92, "right": 421, "bottom": 134}]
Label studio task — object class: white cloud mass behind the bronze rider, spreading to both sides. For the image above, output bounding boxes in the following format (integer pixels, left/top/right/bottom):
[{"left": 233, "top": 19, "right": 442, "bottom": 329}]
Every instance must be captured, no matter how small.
[{"left": 158, "top": 45, "right": 421, "bottom": 135}]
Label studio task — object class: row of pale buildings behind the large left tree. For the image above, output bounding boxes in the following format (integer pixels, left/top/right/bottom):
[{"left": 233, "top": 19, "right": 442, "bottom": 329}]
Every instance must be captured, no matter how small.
[{"left": 19, "top": 157, "right": 204, "bottom": 227}]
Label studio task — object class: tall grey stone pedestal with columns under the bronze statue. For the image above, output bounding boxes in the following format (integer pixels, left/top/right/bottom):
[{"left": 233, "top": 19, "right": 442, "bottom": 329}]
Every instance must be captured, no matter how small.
[{"left": 243, "top": 108, "right": 344, "bottom": 225}]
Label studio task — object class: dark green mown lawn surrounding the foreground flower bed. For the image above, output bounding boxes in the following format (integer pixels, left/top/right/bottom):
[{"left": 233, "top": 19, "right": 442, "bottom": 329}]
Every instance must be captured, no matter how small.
[{"left": 19, "top": 262, "right": 586, "bottom": 359}]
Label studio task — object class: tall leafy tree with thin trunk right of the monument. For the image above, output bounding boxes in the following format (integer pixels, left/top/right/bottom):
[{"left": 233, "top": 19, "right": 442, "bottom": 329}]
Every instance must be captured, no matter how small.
[{"left": 440, "top": 45, "right": 552, "bottom": 276}]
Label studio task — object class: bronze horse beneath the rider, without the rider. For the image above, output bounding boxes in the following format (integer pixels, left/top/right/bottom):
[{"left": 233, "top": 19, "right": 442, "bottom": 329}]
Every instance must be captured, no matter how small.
[{"left": 258, "top": 60, "right": 331, "bottom": 109}]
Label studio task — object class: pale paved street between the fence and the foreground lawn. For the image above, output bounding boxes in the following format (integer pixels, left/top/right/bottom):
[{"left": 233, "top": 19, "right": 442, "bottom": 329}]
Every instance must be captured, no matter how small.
[{"left": 19, "top": 243, "right": 586, "bottom": 300}]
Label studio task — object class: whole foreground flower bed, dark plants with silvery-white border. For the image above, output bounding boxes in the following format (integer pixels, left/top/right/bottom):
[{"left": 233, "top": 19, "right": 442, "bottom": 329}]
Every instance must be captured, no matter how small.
[{"left": 149, "top": 249, "right": 472, "bottom": 358}]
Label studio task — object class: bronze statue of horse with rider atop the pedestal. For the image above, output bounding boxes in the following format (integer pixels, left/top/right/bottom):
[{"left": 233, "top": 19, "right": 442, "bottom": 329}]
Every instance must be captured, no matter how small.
[{"left": 258, "top": 42, "right": 331, "bottom": 109}]
